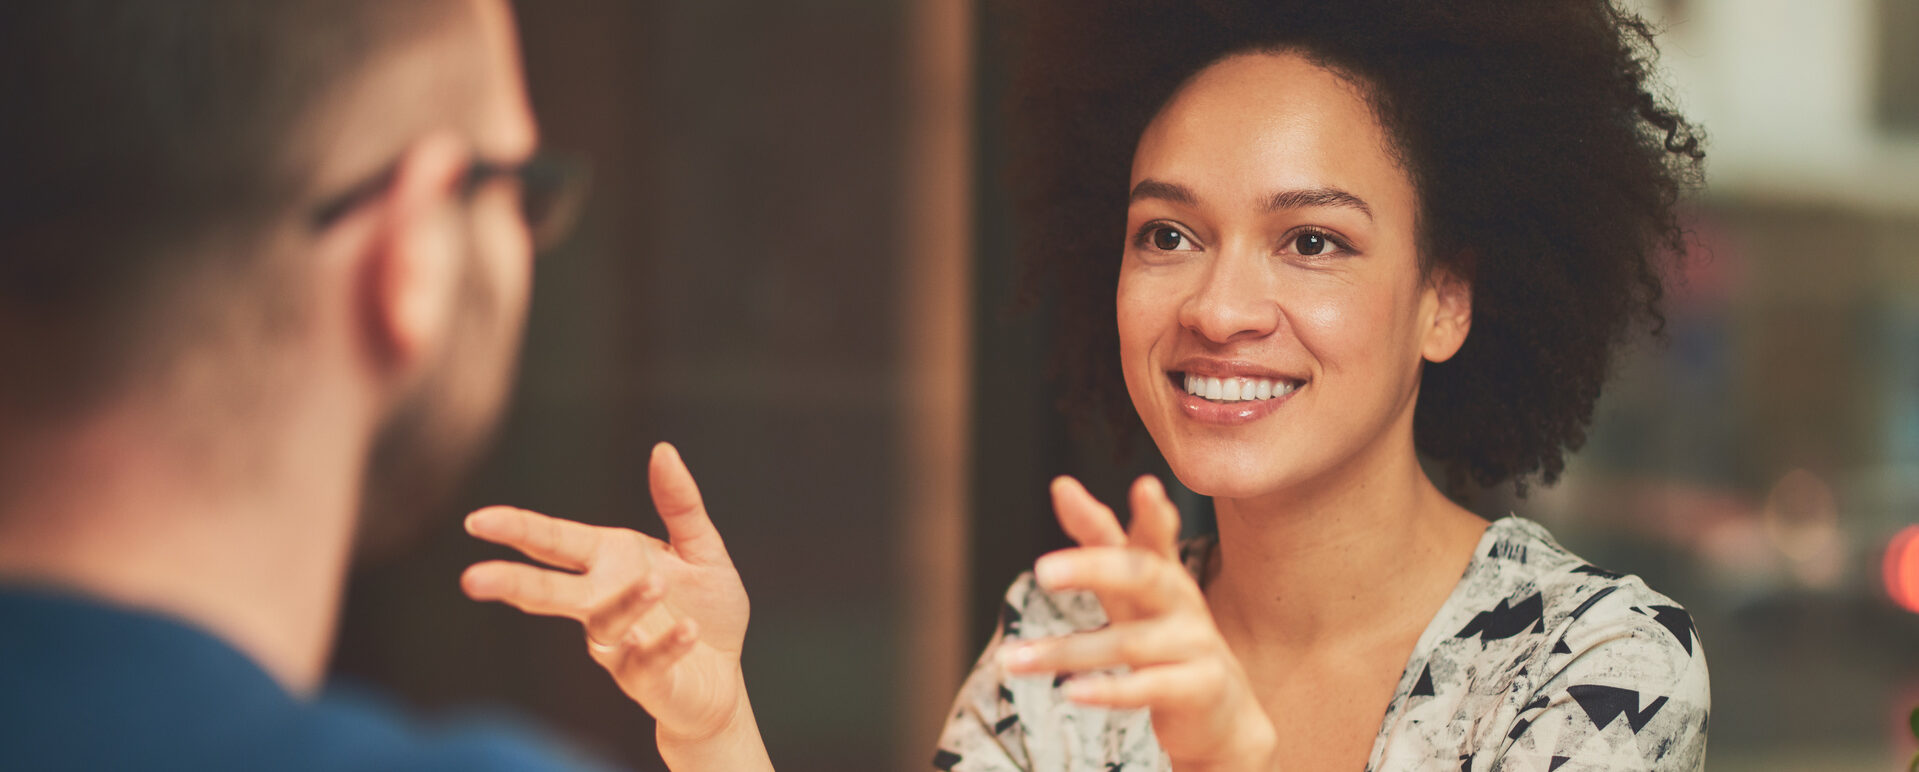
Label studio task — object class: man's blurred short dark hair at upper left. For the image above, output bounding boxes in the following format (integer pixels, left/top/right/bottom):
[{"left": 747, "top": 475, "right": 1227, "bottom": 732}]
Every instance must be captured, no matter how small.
[{"left": 0, "top": 0, "right": 451, "bottom": 422}]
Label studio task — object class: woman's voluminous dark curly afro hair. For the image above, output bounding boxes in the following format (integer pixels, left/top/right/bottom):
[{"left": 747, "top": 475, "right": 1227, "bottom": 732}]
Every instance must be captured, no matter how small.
[{"left": 1007, "top": 0, "right": 1704, "bottom": 494}]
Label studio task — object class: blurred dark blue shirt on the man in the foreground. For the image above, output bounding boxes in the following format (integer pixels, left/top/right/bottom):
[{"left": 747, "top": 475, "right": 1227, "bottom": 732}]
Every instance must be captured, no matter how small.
[{"left": 0, "top": 588, "right": 614, "bottom": 772}]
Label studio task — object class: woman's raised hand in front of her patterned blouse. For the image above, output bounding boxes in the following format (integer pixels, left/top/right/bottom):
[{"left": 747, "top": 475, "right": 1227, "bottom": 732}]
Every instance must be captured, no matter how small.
[{"left": 1000, "top": 476, "right": 1276, "bottom": 772}]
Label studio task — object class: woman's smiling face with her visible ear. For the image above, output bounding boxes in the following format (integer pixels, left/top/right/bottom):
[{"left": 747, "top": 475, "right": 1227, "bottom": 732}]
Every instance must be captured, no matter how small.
[{"left": 1119, "top": 54, "right": 1470, "bottom": 499}]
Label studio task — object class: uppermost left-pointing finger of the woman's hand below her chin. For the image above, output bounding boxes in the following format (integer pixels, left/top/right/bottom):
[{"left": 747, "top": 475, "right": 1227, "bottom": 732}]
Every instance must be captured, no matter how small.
[{"left": 1032, "top": 547, "right": 1182, "bottom": 622}]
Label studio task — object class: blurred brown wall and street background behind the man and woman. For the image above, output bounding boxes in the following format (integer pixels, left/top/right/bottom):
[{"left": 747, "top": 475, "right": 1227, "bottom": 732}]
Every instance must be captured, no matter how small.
[{"left": 338, "top": 0, "right": 1919, "bottom": 772}]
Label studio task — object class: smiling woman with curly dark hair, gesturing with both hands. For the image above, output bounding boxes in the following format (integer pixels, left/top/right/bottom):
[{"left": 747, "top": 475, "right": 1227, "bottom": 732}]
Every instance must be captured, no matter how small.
[{"left": 466, "top": 0, "right": 1708, "bottom": 770}]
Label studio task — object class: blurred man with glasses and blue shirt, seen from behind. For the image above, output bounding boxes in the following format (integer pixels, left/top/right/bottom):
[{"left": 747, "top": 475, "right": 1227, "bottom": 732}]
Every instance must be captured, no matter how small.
[{"left": 0, "top": 0, "right": 606, "bottom": 770}]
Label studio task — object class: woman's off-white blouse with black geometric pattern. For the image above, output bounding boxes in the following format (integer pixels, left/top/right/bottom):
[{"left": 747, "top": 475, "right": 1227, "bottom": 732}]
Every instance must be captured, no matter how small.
[{"left": 933, "top": 517, "right": 1710, "bottom": 772}]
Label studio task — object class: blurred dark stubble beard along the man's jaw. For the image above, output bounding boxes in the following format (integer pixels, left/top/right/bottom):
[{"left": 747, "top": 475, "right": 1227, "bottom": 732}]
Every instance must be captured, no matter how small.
[{"left": 355, "top": 261, "right": 518, "bottom": 563}]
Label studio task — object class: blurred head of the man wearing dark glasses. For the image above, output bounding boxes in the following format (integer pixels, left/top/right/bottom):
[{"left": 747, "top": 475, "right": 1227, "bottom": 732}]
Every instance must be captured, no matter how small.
[{"left": 0, "top": 0, "right": 535, "bottom": 541}]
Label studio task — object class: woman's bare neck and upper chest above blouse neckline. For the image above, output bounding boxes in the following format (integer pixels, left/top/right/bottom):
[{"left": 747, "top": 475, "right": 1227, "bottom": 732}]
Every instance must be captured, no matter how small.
[{"left": 1205, "top": 438, "right": 1485, "bottom": 655}]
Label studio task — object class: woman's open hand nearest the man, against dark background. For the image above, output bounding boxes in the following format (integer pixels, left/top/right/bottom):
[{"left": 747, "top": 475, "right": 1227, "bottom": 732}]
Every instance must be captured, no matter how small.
[{"left": 461, "top": 444, "right": 764, "bottom": 756}]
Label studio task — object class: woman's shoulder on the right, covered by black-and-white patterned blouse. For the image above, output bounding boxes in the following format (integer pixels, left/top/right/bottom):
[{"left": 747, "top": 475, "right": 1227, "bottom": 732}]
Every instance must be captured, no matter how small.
[{"left": 1378, "top": 517, "right": 1712, "bottom": 770}]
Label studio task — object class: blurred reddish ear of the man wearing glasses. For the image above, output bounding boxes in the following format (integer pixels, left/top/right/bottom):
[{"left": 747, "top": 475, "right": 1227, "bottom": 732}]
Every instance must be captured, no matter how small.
[{"left": 361, "top": 134, "right": 468, "bottom": 376}]
